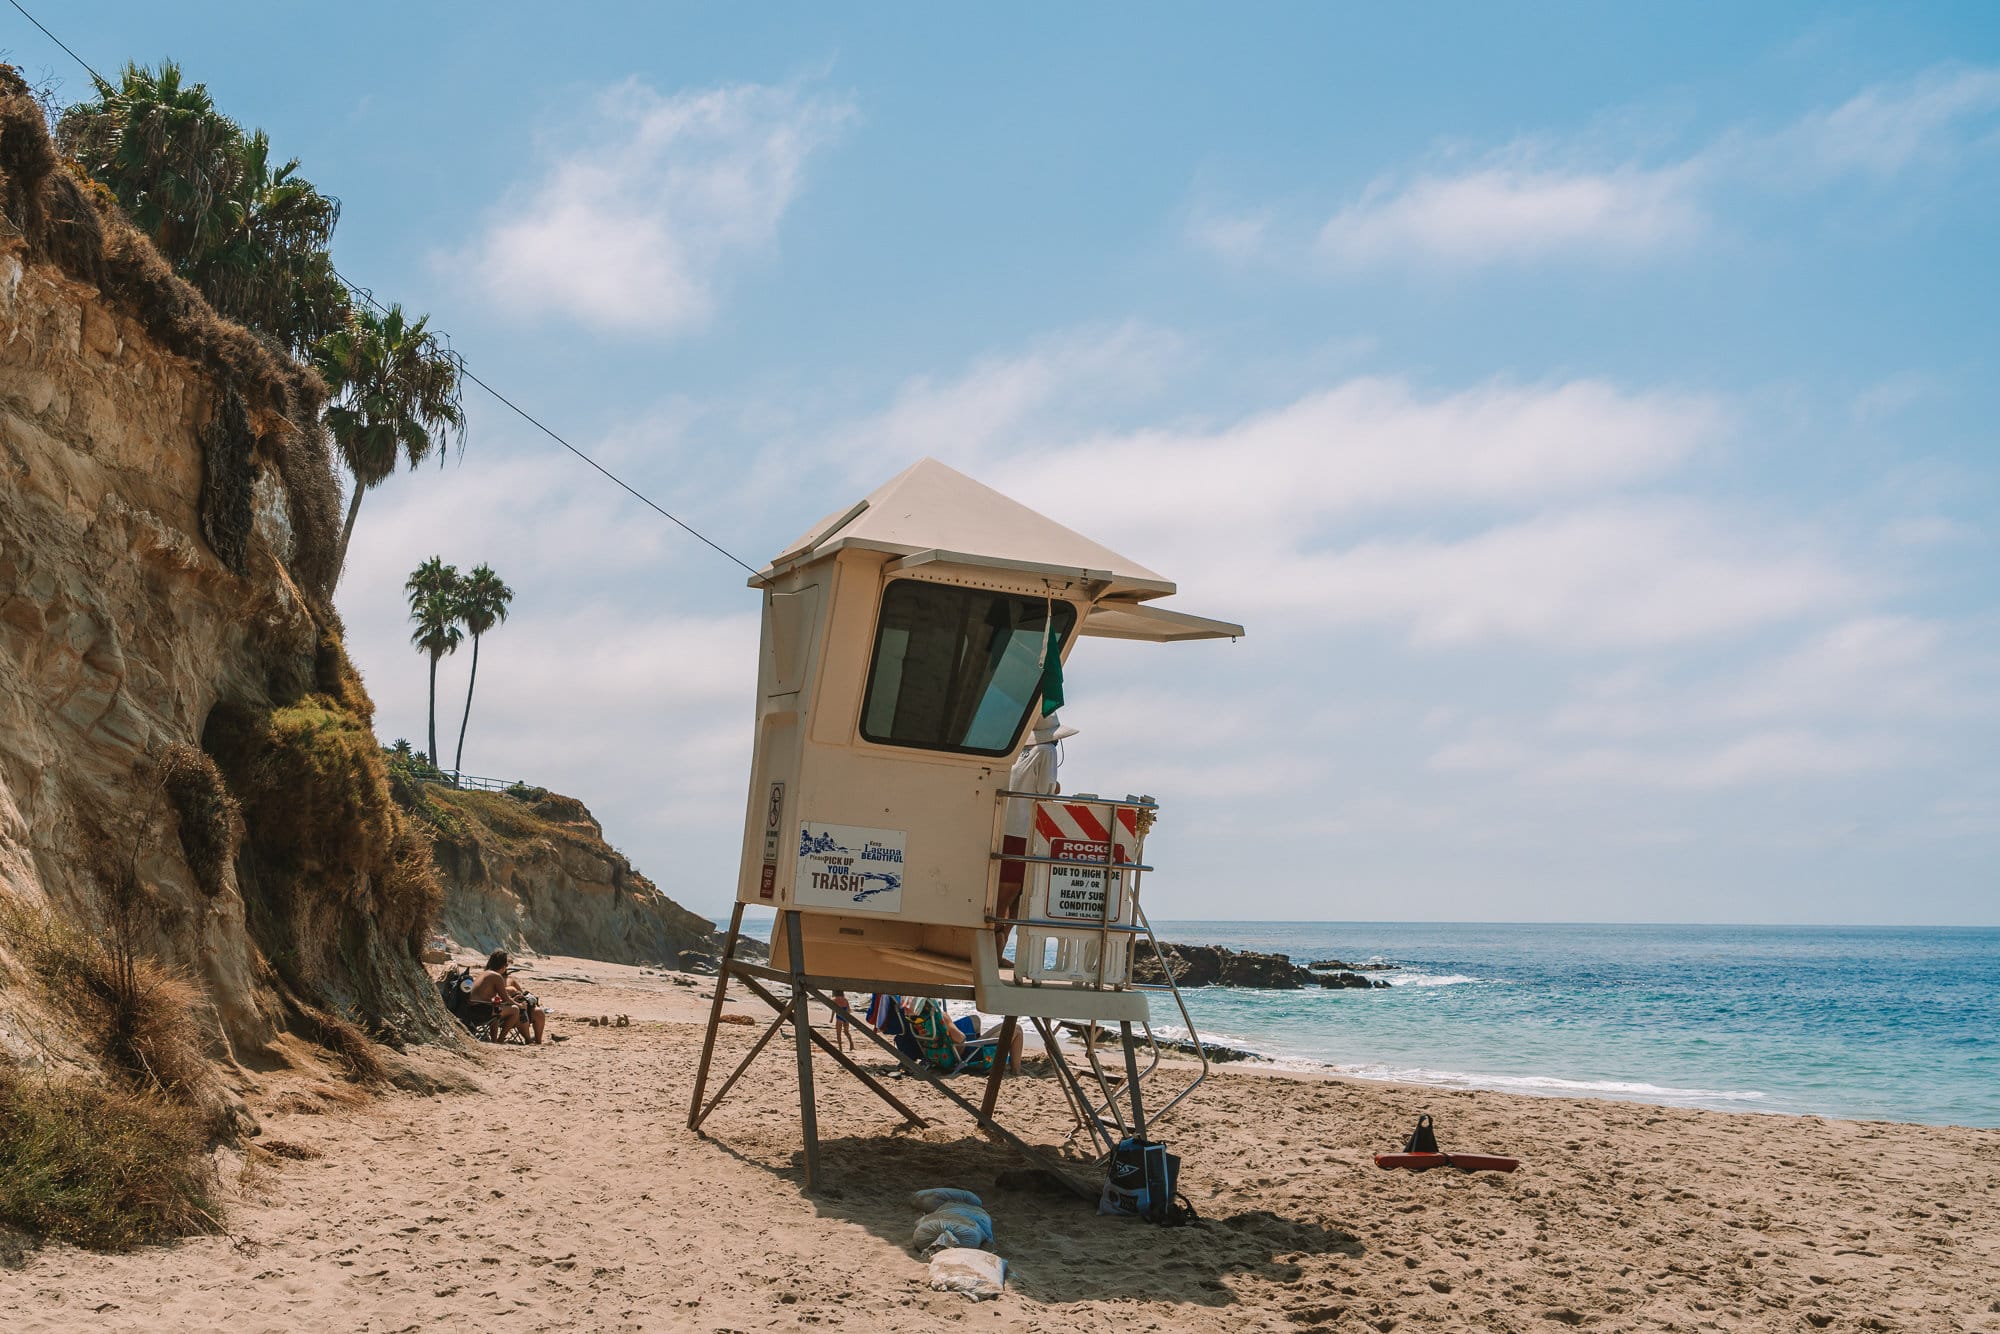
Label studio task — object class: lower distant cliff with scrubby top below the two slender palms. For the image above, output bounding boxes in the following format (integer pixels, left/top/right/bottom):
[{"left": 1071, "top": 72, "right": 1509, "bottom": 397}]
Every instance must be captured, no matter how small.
[{"left": 420, "top": 784, "right": 722, "bottom": 968}]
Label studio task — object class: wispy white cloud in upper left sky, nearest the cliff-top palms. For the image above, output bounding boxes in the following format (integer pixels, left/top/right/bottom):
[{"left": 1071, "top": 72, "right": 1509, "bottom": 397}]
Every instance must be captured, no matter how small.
[{"left": 460, "top": 78, "right": 852, "bottom": 334}]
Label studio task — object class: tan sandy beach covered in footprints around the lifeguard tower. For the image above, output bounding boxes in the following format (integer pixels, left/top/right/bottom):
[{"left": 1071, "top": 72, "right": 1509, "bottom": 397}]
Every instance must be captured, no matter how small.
[{"left": 0, "top": 958, "right": 2000, "bottom": 1334}]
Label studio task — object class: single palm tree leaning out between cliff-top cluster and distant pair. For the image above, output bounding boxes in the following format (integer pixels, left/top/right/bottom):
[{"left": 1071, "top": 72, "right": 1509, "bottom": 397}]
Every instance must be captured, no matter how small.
[{"left": 326, "top": 306, "right": 466, "bottom": 588}]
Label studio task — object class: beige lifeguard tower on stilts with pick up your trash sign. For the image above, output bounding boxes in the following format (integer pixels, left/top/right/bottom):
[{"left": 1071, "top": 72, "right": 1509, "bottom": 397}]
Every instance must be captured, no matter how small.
[{"left": 688, "top": 458, "right": 1242, "bottom": 1192}]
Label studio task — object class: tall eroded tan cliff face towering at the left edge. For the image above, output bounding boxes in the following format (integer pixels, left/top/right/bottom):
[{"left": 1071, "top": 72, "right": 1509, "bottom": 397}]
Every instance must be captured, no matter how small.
[{"left": 0, "top": 70, "right": 450, "bottom": 1068}]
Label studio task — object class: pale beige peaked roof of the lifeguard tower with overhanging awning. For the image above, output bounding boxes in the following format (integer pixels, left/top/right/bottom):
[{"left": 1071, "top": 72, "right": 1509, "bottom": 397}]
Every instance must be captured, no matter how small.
[{"left": 750, "top": 458, "right": 1242, "bottom": 640}]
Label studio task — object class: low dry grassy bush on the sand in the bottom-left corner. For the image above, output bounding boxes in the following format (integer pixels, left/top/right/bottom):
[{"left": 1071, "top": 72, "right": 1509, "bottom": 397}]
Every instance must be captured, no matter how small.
[{"left": 0, "top": 1066, "right": 220, "bottom": 1250}]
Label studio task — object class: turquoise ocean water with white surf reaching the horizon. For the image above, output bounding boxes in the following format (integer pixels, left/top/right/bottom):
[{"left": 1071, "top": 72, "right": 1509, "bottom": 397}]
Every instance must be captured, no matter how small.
[{"left": 1154, "top": 922, "right": 2000, "bottom": 1126}]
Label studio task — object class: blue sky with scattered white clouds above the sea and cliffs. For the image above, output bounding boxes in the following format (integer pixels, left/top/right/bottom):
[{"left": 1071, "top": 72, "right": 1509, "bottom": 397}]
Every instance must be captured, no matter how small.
[{"left": 15, "top": 0, "right": 2000, "bottom": 924}]
